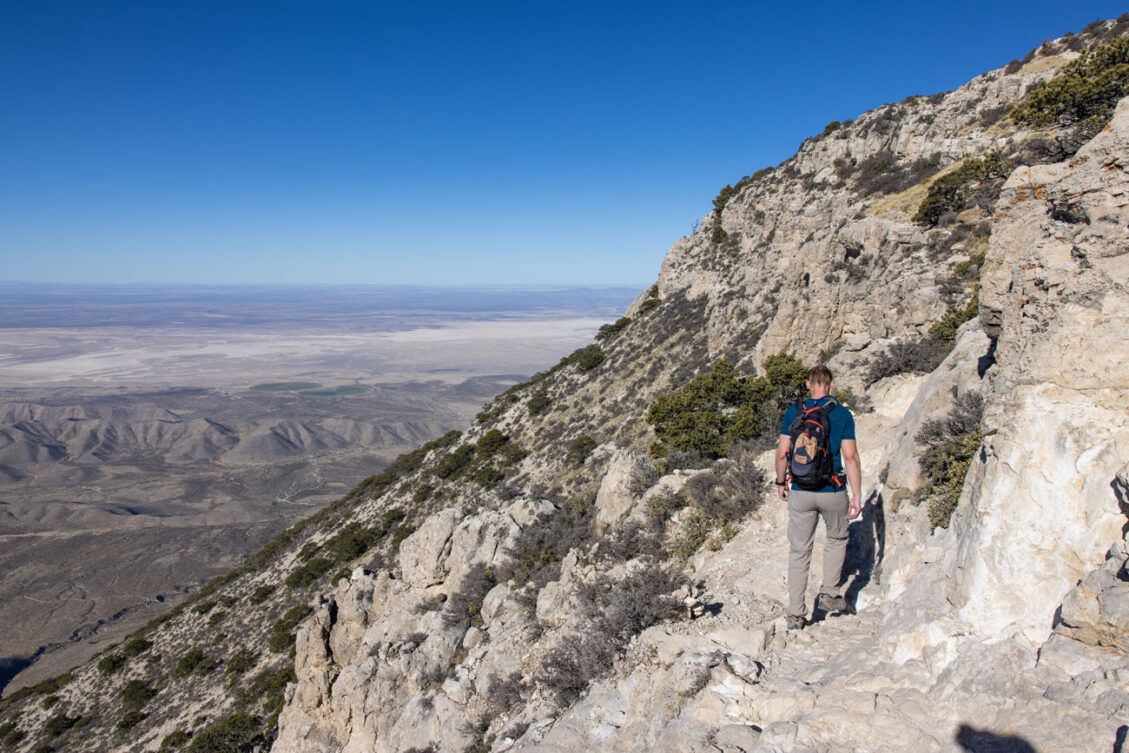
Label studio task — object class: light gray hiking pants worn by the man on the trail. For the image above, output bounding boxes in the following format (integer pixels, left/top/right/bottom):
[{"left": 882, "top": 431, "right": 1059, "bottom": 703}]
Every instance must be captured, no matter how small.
[{"left": 788, "top": 489, "right": 848, "bottom": 616}]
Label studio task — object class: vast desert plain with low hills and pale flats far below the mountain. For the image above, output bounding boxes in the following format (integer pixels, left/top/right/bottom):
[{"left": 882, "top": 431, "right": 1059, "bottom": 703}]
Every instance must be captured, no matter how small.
[{"left": 0, "top": 283, "right": 638, "bottom": 688}]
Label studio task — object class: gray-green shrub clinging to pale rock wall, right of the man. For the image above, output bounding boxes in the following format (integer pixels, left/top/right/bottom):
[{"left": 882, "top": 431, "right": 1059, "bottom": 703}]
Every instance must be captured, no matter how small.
[{"left": 916, "top": 392, "right": 983, "bottom": 528}]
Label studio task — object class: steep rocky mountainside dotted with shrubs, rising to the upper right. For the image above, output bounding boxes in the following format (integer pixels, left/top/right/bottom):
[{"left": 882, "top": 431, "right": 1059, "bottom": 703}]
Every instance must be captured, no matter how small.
[{"left": 0, "top": 19, "right": 1129, "bottom": 753}]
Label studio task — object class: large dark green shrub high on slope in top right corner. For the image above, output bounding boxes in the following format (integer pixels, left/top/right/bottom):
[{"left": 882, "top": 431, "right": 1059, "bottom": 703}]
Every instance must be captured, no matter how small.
[{"left": 1010, "top": 36, "right": 1129, "bottom": 133}]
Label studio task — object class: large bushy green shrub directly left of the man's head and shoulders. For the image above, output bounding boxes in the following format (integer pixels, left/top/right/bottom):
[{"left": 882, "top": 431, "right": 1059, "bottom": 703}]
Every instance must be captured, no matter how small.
[{"left": 647, "top": 353, "right": 807, "bottom": 457}]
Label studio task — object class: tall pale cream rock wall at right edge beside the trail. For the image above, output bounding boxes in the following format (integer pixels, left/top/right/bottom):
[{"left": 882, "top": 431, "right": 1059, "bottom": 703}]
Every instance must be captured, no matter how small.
[{"left": 952, "top": 102, "right": 1129, "bottom": 642}]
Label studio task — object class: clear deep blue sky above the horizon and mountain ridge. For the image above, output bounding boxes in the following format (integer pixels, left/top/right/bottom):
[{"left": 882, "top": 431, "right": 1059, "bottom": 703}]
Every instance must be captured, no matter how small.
[{"left": 0, "top": 0, "right": 1124, "bottom": 284}]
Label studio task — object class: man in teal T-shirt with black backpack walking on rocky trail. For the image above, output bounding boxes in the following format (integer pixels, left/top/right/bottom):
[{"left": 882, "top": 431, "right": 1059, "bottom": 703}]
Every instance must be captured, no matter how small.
[{"left": 776, "top": 366, "right": 863, "bottom": 630}]
